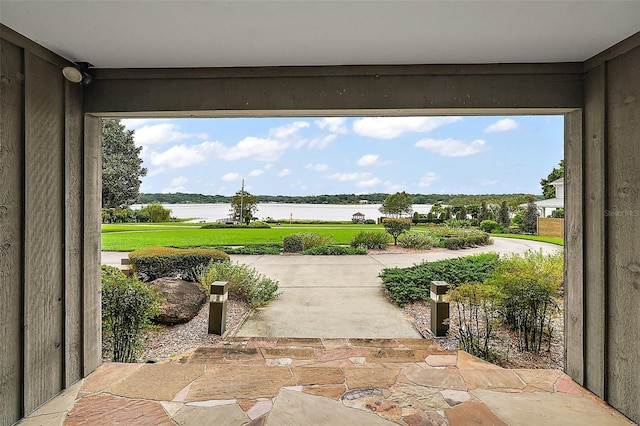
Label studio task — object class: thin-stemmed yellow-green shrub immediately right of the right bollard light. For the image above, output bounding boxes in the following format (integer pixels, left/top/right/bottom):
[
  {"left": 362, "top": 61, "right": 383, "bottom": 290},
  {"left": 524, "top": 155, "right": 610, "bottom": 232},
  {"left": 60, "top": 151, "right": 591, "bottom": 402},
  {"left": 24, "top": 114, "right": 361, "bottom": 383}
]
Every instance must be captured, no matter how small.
[{"left": 447, "top": 283, "right": 500, "bottom": 361}]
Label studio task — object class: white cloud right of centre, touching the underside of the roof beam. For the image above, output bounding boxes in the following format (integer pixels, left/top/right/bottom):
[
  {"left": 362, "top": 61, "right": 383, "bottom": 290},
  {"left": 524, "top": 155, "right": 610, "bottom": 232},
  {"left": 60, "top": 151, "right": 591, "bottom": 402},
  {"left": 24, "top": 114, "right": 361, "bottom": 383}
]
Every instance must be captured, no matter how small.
[{"left": 353, "top": 117, "right": 462, "bottom": 139}]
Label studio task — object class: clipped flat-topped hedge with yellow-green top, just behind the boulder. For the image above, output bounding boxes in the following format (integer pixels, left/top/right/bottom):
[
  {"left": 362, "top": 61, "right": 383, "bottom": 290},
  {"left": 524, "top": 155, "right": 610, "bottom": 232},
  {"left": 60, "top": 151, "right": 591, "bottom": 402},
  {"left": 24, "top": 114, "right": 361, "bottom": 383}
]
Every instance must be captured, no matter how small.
[{"left": 129, "top": 247, "right": 229, "bottom": 281}]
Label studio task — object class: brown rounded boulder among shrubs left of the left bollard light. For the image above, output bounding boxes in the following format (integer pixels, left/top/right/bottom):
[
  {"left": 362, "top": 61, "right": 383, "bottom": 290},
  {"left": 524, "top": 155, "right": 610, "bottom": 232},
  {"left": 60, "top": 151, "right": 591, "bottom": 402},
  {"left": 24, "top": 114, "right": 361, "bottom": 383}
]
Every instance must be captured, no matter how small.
[{"left": 149, "top": 277, "right": 207, "bottom": 324}]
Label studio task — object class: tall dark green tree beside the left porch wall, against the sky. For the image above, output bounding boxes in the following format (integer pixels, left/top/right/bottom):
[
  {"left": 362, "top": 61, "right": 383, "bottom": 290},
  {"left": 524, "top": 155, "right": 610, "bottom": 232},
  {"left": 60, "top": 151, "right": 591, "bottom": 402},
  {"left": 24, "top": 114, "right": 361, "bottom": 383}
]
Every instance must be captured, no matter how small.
[{"left": 102, "top": 120, "right": 147, "bottom": 208}]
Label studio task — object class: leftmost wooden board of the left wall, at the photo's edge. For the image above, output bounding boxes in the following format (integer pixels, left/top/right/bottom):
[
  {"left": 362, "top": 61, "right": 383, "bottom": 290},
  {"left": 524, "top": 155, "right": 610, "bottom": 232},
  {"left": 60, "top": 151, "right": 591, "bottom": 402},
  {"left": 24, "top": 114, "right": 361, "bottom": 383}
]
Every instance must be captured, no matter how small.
[{"left": 0, "top": 35, "right": 24, "bottom": 425}]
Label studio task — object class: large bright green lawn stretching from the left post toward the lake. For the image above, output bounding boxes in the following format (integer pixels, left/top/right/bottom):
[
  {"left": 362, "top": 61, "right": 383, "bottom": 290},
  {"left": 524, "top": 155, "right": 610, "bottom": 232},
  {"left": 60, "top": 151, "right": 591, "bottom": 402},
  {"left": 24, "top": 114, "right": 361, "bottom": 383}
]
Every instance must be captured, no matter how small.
[{"left": 102, "top": 223, "right": 384, "bottom": 251}]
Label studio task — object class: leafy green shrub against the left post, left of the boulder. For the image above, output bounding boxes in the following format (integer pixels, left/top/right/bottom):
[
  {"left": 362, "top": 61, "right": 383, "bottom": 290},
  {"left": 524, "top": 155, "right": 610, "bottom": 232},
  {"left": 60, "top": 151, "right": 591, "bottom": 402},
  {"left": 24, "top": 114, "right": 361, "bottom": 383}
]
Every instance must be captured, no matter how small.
[{"left": 101, "top": 265, "right": 162, "bottom": 362}]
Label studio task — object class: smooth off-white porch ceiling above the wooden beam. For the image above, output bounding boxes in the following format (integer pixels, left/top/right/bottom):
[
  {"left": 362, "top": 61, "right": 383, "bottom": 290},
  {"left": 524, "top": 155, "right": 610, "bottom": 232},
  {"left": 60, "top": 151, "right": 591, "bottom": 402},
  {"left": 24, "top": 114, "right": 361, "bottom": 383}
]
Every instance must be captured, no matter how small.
[{"left": 0, "top": 0, "right": 640, "bottom": 68}]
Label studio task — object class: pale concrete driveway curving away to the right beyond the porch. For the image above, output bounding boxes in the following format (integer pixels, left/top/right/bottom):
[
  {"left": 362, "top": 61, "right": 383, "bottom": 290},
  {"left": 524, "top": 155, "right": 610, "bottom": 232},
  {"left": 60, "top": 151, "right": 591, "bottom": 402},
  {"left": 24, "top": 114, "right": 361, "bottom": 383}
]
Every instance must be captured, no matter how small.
[{"left": 102, "top": 238, "right": 562, "bottom": 338}]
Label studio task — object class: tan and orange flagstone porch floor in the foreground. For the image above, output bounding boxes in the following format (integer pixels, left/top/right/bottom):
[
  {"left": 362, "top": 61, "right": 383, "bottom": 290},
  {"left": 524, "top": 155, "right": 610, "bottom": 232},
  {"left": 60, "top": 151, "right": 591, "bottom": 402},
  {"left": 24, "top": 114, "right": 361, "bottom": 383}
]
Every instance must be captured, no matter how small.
[{"left": 21, "top": 338, "right": 632, "bottom": 426}]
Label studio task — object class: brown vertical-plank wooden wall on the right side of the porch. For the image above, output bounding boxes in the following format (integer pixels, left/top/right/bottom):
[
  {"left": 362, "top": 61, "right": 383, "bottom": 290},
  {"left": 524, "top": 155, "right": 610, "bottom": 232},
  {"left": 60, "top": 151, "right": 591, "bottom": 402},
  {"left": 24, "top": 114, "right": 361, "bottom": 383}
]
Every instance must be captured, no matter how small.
[{"left": 565, "top": 34, "right": 640, "bottom": 422}]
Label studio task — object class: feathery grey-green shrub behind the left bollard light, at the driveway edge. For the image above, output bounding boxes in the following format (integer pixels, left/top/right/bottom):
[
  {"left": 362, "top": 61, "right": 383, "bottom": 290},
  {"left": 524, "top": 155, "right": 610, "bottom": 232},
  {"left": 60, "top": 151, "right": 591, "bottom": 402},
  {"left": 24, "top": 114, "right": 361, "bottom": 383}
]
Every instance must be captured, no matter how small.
[{"left": 198, "top": 261, "right": 279, "bottom": 307}]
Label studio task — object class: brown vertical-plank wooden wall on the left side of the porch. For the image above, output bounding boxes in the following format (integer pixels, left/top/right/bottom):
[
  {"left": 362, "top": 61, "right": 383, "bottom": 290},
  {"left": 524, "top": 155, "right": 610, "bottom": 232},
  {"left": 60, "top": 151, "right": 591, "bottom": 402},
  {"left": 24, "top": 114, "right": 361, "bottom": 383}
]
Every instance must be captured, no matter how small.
[{"left": 0, "top": 27, "right": 101, "bottom": 425}]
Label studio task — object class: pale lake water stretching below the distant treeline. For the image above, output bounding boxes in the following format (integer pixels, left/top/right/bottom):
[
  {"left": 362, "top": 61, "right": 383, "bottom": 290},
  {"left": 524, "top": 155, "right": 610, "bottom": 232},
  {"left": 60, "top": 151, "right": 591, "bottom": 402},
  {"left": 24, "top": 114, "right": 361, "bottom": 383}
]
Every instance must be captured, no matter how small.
[{"left": 131, "top": 203, "right": 431, "bottom": 222}]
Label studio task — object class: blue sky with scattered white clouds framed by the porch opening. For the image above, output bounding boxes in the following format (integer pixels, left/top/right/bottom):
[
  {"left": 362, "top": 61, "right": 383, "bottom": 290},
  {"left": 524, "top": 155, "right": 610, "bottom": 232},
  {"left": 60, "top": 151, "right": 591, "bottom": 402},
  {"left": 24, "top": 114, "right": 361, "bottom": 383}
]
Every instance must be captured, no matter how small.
[{"left": 122, "top": 116, "right": 564, "bottom": 195}]
